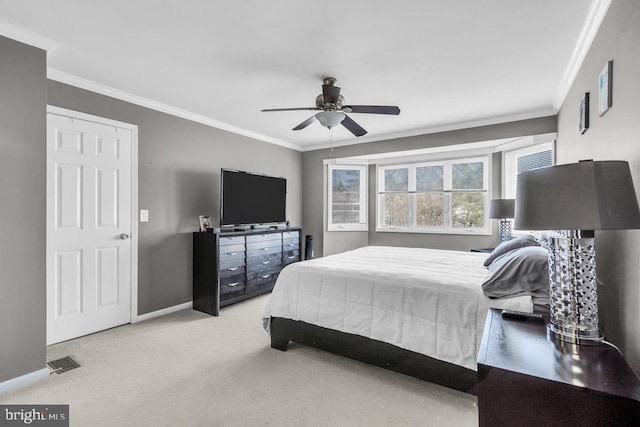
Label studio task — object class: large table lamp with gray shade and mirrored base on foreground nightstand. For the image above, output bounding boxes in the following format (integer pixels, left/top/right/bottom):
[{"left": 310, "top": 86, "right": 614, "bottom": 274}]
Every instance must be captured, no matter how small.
[{"left": 515, "top": 160, "right": 640, "bottom": 344}]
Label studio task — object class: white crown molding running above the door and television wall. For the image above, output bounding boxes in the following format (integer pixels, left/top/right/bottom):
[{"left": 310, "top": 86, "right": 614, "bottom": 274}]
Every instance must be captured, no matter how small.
[{"left": 47, "top": 68, "right": 302, "bottom": 151}]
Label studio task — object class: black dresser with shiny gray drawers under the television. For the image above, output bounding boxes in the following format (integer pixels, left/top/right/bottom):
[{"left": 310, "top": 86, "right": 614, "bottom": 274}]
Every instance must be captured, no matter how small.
[{"left": 193, "top": 227, "right": 301, "bottom": 316}]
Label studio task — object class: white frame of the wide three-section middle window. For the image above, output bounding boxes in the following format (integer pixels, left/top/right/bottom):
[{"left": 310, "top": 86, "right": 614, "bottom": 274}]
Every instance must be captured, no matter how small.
[{"left": 375, "top": 154, "right": 492, "bottom": 236}]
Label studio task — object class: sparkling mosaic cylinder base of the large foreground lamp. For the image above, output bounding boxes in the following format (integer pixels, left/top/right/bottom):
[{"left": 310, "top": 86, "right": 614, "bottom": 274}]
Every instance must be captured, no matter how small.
[{"left": 547, "top": 230, "right": 604, "bottom": 344}]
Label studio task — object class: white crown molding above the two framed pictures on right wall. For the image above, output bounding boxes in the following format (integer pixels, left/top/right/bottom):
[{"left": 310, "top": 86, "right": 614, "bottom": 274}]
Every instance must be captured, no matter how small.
[{"left": 553, "top": 0, "right": 611, "bottom": 113}]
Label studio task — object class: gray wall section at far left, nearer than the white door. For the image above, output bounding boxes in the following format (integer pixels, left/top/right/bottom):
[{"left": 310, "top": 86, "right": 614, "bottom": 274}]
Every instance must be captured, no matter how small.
[{"left": 0, "top": 36, "right": 47, "bottom": 382}]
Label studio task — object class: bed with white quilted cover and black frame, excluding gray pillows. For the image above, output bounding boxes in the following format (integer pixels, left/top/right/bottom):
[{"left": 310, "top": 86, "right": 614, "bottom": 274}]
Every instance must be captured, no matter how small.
[{"left": 263, "top": 241, "right": 546, "bottom": 391}]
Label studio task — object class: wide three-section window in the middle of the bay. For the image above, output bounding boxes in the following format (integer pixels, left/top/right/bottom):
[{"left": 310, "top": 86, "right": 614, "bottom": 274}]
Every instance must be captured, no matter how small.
[{"left": 377, "top": 156, "right": 490, "bottom": 234}]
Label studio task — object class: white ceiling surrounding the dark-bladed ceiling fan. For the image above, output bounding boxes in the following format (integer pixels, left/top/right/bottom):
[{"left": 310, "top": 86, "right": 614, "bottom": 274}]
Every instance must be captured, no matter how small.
[{"left": 0, "top": 0, "right": 611, "bottom": 150}]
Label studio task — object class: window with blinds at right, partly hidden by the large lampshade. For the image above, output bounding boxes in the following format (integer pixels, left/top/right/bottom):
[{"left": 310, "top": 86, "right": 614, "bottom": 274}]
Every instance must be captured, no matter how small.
[{"left": 502, "top": 141, "right": 555, "bottom": 199}]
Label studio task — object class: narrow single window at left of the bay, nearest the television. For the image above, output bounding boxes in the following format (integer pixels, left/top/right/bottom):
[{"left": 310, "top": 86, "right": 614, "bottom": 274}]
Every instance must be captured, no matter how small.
[{"left": 327, "top": 165, "right": 368, "bottom": 231}]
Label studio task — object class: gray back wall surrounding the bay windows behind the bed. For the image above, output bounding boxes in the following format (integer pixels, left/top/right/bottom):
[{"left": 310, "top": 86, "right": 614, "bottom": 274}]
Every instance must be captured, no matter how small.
[{"left": 302, "top": 116, "right": 557, "bottom": 256}]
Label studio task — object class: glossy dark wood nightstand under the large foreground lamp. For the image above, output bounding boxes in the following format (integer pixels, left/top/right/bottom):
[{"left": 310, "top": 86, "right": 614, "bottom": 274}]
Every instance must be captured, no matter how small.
[{"left": 477, "top": 309, "right": 640, "bottom": 426}]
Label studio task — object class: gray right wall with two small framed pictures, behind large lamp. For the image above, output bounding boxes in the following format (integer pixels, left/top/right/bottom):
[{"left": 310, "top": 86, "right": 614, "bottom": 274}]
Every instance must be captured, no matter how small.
[{"left": 557, "top": 1, "right": 640, "bottom": 373}]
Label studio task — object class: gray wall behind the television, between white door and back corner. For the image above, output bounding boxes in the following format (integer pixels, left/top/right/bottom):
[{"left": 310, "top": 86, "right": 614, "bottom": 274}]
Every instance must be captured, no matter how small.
[{"left": 47, "top": 81, "right": 302, "bottom": 314}]
